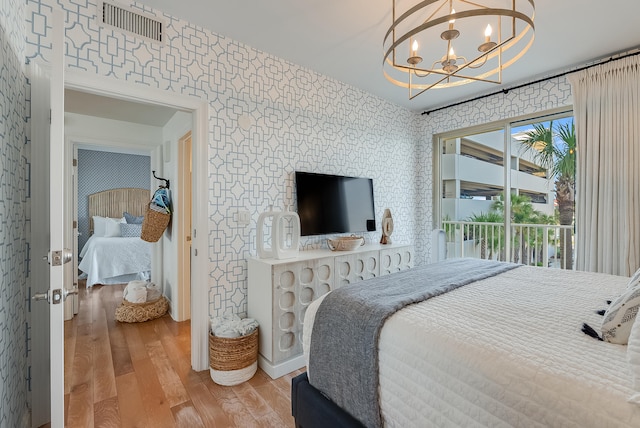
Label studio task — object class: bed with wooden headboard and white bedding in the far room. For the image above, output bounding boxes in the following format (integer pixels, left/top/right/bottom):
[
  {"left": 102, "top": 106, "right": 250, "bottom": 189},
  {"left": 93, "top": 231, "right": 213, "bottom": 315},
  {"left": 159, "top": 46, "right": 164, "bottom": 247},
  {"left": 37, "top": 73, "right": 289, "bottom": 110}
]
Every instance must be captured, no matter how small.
[{"left": 78, "top": 188, "right": 151, "bottom": 287}]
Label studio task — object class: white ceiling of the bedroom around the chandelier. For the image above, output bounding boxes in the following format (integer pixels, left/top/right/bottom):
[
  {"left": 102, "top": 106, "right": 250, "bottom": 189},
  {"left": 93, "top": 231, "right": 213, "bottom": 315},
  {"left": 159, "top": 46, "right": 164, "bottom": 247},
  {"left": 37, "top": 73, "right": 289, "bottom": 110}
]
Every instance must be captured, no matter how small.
[{"left": 126, "top": 0, "right": 640, "bottom": 111}]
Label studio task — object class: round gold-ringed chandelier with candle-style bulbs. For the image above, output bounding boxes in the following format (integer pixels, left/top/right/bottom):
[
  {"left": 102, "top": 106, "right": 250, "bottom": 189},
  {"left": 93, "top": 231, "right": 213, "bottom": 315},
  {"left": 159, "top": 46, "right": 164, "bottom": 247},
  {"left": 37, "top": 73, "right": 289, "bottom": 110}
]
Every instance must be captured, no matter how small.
[{"left": 383, "top": 0, "right": 535, "bottom": 99}]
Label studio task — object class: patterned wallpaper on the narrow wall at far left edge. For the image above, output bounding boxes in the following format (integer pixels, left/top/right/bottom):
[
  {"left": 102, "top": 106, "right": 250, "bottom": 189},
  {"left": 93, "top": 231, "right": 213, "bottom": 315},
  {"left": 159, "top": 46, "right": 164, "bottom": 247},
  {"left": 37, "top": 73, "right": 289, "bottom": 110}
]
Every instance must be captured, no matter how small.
[{"left": 0, "top": 0, "right": 30, "bottom": 427}]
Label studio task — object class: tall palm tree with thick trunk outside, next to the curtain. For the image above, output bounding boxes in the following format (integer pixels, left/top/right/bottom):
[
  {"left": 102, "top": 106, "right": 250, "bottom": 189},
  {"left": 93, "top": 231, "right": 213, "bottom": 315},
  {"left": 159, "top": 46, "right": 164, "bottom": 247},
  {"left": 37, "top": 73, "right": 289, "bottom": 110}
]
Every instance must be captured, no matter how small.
[{"left": 520, "top": 120, "right": 576, "bottom": 269}]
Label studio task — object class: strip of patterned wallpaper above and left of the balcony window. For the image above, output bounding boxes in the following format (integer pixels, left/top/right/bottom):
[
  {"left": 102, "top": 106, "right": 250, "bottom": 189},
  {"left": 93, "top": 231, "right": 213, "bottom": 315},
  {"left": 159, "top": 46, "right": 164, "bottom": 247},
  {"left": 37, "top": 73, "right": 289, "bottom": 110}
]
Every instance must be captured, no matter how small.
[{"left": 414, "top": 76, "right": 573, "bottom": 257}]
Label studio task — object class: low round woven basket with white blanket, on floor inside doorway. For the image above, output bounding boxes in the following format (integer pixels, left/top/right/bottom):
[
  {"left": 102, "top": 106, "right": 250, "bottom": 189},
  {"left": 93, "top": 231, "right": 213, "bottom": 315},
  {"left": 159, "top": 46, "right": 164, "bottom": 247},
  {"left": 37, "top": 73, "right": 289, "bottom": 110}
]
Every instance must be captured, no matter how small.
[{"left": 116, "top": 280, "right": 169, "bottom": 323}]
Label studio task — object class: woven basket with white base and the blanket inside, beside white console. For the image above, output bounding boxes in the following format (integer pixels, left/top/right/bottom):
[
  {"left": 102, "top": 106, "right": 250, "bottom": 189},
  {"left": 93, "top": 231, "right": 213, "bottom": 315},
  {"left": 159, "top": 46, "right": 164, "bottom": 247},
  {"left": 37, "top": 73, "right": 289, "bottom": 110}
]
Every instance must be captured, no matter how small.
[{"left": 209, "top": 315, "right": 258, "bottom": 386}]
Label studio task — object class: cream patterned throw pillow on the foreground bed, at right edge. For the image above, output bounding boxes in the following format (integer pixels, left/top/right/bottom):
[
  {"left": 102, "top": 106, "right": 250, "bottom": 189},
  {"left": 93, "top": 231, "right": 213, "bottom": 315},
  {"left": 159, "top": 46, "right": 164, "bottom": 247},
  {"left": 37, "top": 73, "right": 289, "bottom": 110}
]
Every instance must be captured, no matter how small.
[{"left": 601, "top": 282, "right": 640, "bottom": 345}]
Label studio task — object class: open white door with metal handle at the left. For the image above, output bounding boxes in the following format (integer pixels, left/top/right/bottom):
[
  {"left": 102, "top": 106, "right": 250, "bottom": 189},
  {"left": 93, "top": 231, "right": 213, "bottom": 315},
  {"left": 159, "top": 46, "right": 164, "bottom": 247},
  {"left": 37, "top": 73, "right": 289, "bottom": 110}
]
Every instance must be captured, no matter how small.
[{"left": 31, "top": 12, "right": 70, "bottom": 428}]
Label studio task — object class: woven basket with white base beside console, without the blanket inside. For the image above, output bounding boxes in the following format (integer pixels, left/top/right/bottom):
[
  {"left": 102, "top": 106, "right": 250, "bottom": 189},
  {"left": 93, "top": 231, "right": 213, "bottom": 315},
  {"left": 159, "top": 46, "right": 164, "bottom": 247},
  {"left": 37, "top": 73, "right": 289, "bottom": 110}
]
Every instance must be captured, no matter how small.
[{"left": 209, "top": 328, "right": 258, "bottom": 385}]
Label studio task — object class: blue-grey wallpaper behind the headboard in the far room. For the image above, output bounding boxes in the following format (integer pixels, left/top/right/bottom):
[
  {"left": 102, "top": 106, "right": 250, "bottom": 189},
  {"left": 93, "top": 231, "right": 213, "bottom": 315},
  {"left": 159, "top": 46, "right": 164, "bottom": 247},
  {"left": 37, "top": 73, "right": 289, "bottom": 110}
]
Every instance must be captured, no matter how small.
[{"left": 78, "top": 149, "right": 151, "bottom": 249}]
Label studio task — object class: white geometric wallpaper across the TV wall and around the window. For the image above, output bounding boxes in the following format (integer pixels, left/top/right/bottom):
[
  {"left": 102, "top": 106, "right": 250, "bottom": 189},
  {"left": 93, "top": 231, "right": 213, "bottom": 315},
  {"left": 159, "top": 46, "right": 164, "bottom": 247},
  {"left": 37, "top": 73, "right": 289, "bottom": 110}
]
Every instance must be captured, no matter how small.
[{"left": 26, "top": 0, "right": 570, "bottom": 324}]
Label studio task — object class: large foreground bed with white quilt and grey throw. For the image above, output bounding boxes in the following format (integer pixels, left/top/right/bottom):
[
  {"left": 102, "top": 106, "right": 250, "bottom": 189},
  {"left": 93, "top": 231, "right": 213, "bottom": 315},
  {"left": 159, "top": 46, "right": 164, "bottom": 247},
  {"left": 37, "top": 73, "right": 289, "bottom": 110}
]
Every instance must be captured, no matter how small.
[{"left": 291, "top": 259, "right": 640, "bottom": 428}]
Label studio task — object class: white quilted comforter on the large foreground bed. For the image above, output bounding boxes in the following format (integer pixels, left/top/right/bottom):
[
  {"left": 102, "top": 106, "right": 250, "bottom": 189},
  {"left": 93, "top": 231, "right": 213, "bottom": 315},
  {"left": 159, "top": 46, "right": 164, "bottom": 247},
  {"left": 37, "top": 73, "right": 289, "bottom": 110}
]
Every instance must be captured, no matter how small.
[{"left": 303, "top": 266, "right": 640, "bottom": 428}]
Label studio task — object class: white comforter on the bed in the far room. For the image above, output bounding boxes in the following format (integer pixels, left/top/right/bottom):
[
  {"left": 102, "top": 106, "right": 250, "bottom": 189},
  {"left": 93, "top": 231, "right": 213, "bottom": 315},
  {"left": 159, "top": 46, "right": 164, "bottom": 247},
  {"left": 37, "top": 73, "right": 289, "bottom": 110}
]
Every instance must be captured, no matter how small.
[{"left": 78, "top": 236, "right": 151, "bottom": 287}]
